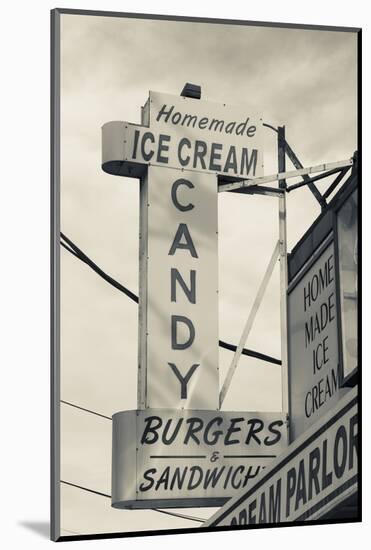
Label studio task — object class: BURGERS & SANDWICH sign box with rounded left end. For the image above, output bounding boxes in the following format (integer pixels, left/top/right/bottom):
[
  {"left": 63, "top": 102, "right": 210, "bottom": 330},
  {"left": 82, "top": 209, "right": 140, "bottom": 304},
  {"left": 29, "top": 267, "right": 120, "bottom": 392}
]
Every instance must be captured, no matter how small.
[{"left": 112, "top": 409, "right": 287, "bottom": 508}]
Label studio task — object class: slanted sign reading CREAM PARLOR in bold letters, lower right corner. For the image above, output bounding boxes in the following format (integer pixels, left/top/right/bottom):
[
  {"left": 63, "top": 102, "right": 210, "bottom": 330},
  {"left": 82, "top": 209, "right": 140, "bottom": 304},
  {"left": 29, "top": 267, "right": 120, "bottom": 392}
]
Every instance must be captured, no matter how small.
[{"left": 203, "top": 388, "right": 358, "bottom": 527}]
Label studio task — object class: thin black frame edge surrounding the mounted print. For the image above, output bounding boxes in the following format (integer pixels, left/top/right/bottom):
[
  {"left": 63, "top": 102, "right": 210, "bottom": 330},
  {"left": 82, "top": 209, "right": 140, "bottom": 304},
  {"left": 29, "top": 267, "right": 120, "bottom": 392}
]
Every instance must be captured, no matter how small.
[{"left": 50, "top": 8, "right": 362, "bottom": 541}]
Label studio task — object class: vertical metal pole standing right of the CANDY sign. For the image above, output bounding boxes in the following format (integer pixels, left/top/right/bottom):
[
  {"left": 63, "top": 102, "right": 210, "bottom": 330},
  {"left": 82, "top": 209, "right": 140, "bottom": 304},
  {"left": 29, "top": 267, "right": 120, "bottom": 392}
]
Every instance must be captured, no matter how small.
[{"left": 278, "top": 126, "right": 289, "bottom": 414}]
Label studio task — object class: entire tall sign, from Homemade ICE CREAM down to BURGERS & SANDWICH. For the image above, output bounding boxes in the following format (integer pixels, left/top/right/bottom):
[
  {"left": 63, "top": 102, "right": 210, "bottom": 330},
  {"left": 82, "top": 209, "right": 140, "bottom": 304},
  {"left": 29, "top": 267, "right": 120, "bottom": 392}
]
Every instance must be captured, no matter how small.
[{"left": 102, "top": 92, "right": 270, "bottom": 508}]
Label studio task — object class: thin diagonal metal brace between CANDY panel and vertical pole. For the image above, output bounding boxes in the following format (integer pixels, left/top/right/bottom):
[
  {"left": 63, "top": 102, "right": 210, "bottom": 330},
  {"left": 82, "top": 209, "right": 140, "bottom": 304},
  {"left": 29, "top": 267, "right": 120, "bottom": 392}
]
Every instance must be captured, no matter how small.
[{"left": 219, "top": 242, "right": 279, "bottom": 407}]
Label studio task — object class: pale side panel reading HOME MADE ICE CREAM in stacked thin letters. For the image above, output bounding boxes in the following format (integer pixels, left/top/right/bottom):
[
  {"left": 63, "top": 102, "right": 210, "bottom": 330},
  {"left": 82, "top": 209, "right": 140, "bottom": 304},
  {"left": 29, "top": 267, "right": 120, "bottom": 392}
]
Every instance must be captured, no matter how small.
[{"left": 288, "top": 242, "right": 347, "bottom": 440}]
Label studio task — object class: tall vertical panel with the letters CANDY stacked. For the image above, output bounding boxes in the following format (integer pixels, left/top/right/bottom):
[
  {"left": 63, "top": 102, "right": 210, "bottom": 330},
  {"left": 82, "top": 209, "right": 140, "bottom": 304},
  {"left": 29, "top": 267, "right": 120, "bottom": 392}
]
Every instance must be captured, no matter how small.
[{"left": 139, "top": 166, "right": 219, "bottom": 409}]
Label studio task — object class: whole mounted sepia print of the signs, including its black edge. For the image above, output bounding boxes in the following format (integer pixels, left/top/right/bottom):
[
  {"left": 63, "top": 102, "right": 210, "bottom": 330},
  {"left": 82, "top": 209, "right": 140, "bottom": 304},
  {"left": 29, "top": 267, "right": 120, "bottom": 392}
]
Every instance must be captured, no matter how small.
[{"left": 51, "top": 9, "right": 361, "bottom": 541}]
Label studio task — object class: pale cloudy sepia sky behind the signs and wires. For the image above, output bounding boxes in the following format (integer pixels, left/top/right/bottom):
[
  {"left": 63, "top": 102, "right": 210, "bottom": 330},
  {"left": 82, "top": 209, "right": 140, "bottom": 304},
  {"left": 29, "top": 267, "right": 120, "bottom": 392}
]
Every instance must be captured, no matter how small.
[{"left": 61, "top": 15, "right": 357, "bottom": 535}]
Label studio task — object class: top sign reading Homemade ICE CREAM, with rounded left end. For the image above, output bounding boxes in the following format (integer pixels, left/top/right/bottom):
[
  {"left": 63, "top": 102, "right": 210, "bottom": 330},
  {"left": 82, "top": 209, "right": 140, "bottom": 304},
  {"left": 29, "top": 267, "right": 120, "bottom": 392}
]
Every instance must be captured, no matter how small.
[{"left": 103, "top": 92, "right": 263, "bottom": 178}]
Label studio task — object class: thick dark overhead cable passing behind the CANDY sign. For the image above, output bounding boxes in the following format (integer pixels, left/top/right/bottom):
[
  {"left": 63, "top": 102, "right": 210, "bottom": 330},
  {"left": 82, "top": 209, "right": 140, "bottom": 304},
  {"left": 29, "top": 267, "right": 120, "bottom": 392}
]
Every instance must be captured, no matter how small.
[{"left": 61, "top": 232, "right": 282, "bottom": 365}]
